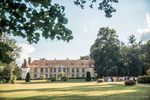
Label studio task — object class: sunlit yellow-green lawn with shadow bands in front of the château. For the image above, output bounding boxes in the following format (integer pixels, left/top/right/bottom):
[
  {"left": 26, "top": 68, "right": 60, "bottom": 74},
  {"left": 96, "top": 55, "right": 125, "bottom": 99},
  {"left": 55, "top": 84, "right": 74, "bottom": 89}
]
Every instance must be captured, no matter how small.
[{"left": 0, "top": 80, "right": 150, "bottom": 100}]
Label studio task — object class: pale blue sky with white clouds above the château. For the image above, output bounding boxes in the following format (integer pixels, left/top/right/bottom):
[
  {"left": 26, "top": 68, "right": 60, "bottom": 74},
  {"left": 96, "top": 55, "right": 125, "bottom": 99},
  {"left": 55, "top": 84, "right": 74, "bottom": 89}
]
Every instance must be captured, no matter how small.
[{"left": 16, "top": 0, "right": 150, "bottom": 64}]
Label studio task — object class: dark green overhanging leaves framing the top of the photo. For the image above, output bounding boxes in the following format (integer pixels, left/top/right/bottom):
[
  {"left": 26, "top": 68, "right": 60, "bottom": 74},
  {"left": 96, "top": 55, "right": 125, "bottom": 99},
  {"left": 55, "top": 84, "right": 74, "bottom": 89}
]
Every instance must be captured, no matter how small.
[{"left": 0, "top": 0, "right": 118, "bottom": 43}]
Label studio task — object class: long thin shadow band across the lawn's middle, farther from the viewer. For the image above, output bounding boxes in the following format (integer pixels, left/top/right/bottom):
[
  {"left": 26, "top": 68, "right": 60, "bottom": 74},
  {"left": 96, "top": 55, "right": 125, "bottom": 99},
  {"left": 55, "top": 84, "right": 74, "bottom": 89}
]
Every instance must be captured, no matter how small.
[{"left": 0, "top": 84, "right": 126, "bottom": 93}]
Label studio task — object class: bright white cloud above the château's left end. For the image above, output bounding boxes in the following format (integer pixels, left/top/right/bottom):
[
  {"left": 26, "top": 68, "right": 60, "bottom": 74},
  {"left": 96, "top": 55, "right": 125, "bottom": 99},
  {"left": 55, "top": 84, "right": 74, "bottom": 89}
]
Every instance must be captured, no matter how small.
[{"left": 17, "top": 43, "right": 35, "bottom": 65}]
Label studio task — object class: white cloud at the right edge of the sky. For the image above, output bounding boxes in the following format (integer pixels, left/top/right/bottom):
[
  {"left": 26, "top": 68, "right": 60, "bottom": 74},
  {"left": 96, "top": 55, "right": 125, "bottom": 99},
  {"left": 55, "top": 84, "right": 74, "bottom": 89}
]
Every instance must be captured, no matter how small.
[{"left": 137, "top": 13, "right": 150, "bottom": 41}]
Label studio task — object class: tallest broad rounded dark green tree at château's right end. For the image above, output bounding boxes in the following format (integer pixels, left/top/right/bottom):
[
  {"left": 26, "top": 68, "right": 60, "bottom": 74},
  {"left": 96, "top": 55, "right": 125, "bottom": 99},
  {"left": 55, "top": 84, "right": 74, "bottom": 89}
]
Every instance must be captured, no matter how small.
[{"left": 90, "top": 27, "right": 120, "bottom": 77}]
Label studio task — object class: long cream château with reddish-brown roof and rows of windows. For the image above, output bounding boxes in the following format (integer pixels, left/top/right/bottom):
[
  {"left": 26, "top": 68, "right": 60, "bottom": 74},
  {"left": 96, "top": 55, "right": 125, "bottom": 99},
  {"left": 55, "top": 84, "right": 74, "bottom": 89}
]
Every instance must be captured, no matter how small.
[{"left": 21, "top": 59, "right": 95, "bottom": 79}]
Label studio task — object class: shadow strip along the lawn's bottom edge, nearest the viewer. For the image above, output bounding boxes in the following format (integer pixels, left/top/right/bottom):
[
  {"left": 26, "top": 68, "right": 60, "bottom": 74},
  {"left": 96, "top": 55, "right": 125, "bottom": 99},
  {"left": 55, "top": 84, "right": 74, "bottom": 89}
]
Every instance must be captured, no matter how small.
[{"left": 0, "top": 93, "right": 150, "bottom": 100}]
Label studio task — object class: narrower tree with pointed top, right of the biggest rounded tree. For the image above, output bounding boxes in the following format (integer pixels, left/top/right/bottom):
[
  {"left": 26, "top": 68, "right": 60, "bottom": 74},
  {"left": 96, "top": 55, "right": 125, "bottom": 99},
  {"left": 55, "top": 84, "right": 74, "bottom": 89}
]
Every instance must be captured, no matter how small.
[{"left": 127, "top": 35, "right": 142, "bottom": 76}]
